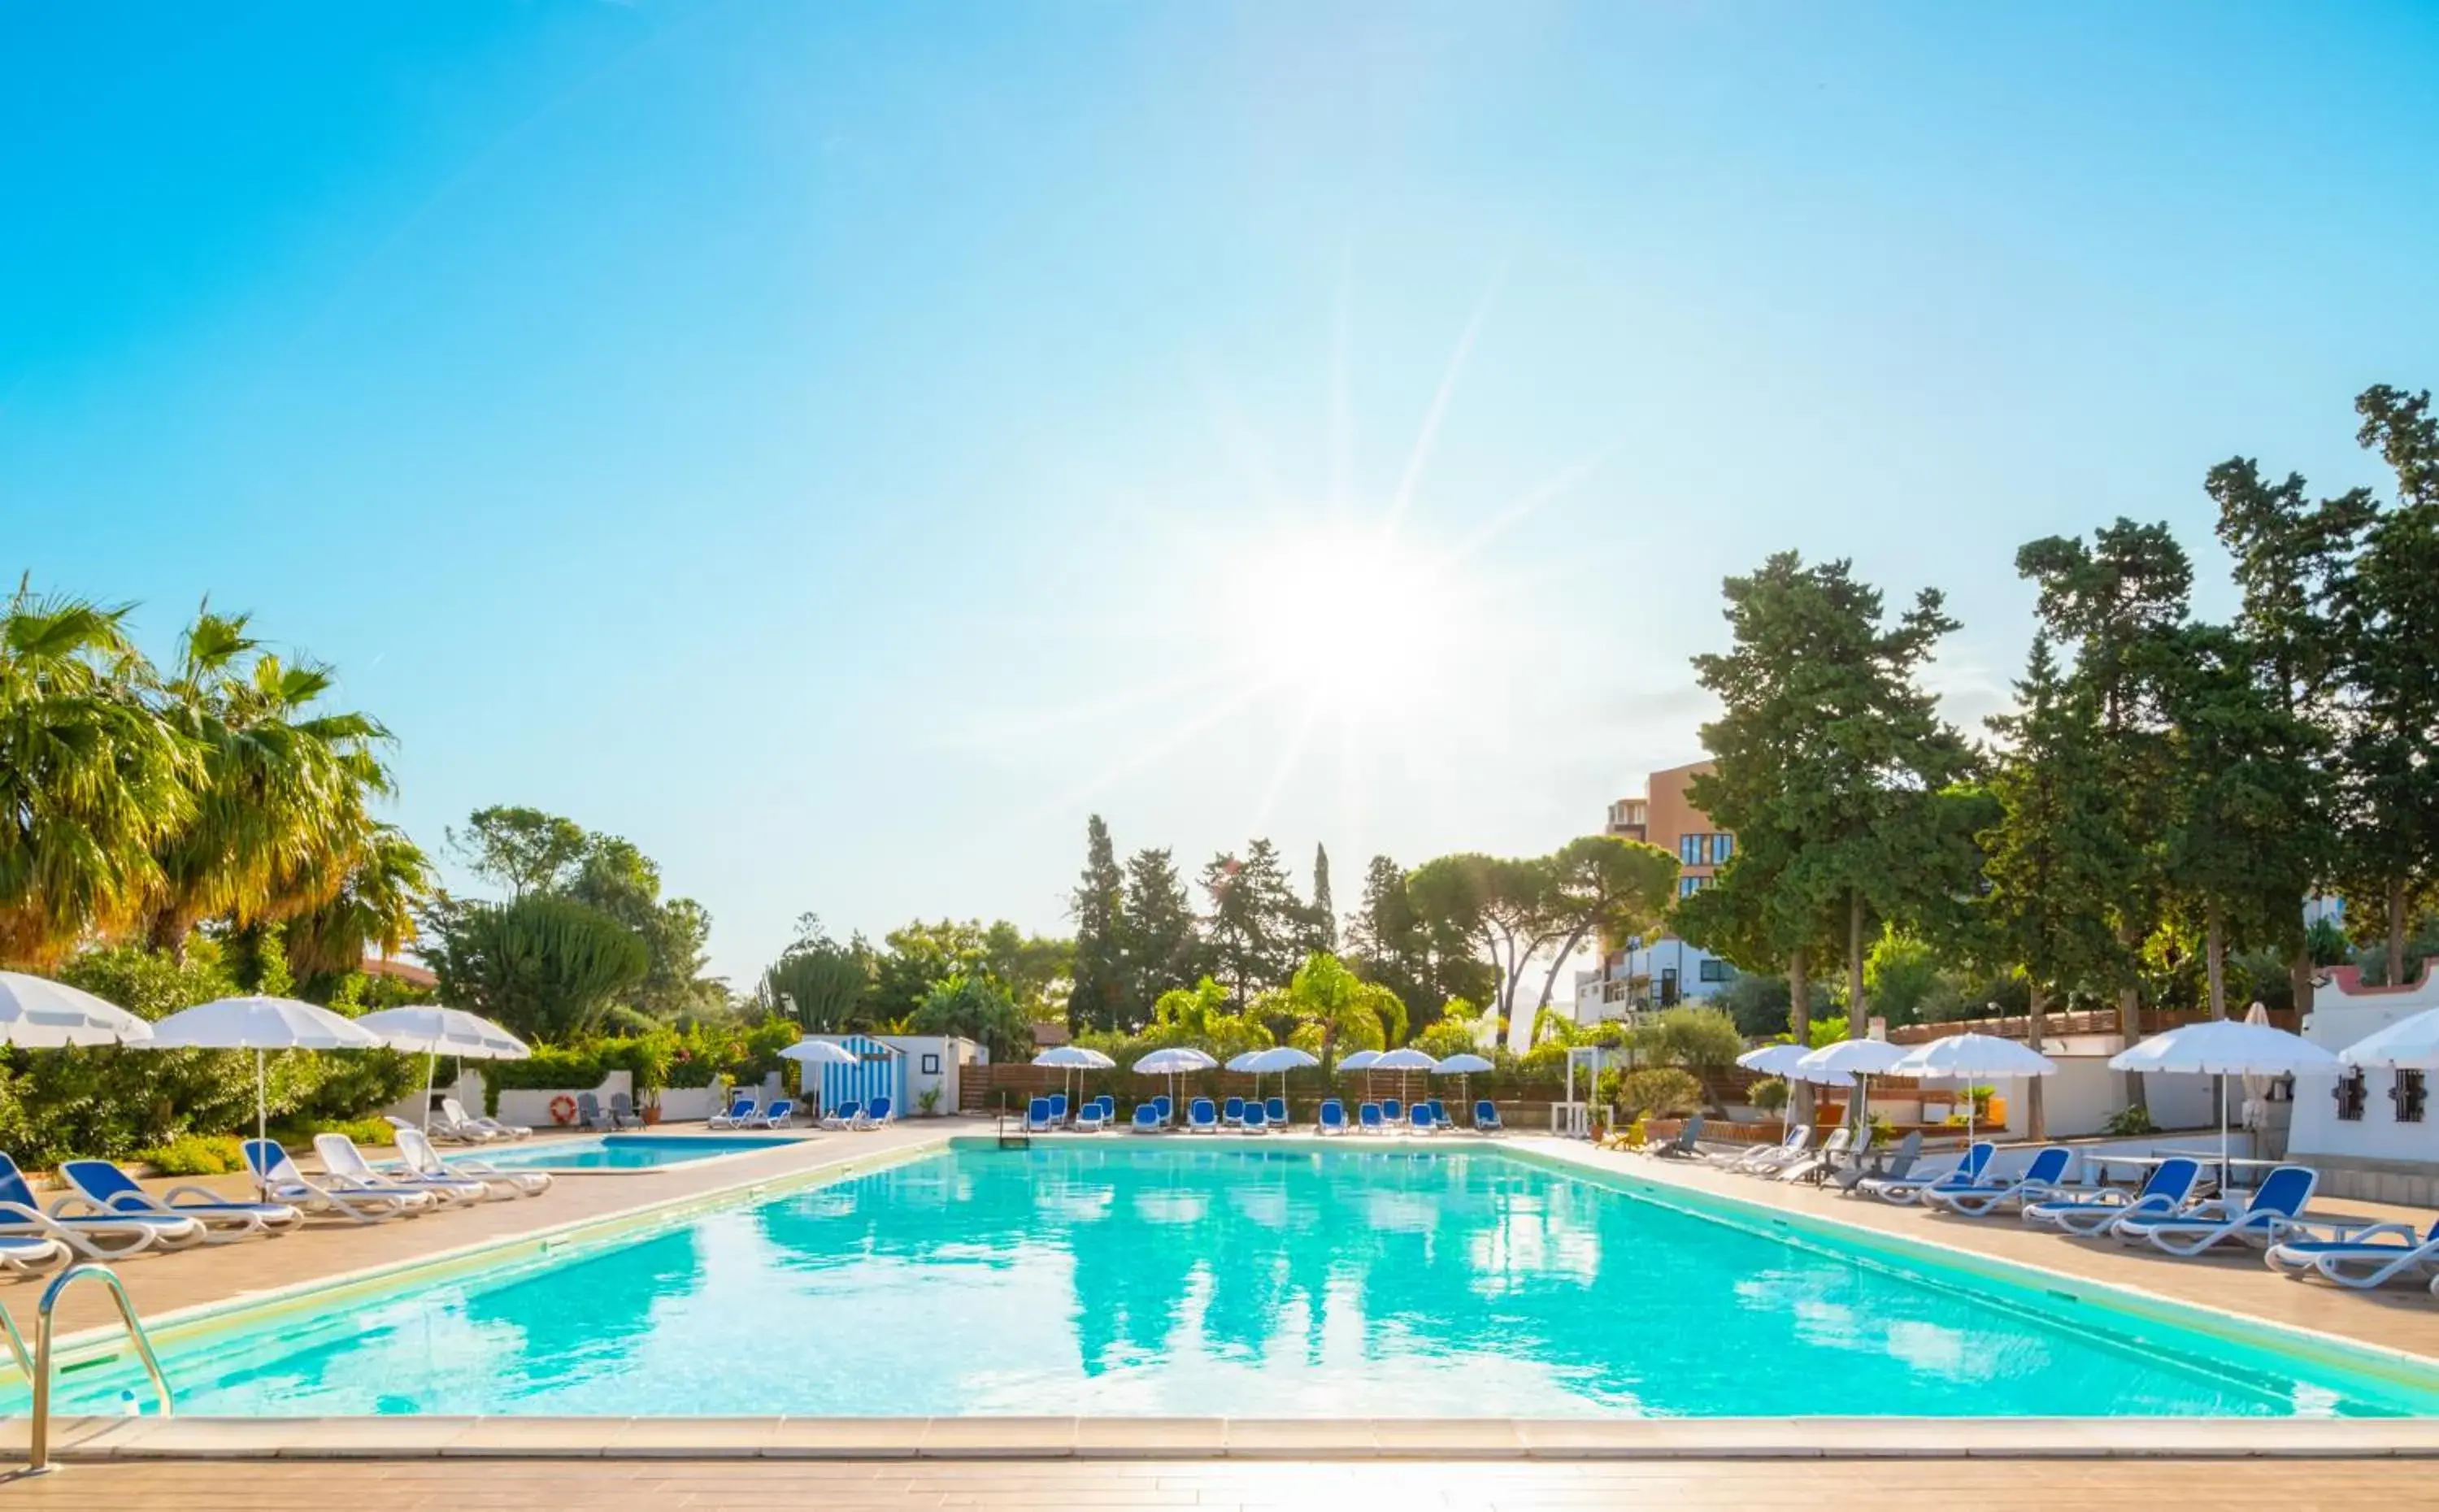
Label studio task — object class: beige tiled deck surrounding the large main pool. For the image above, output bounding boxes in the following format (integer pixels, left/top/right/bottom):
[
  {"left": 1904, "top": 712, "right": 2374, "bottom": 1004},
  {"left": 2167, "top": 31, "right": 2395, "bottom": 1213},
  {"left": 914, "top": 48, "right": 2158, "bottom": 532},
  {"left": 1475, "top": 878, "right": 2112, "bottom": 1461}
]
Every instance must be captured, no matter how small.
[{"left": 14, "top": 1119, "right": 2439, "bottom": 1507}]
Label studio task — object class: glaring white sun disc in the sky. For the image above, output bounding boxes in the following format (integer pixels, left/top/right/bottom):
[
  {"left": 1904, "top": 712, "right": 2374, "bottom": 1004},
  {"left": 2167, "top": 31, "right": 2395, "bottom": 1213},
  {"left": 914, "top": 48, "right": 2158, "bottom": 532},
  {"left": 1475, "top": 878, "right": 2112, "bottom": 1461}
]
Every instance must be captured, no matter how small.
[{"left": 1227, "top": 527, "right": 1456, "bottom": 710}]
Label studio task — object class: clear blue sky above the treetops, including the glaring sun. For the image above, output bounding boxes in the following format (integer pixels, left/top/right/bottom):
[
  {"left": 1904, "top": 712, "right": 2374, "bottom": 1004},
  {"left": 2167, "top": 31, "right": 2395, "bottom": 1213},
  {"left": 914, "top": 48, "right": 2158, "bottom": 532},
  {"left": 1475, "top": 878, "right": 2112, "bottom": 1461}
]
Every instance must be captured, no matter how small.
[{"left": 0, "top": 0, "right": 2439, "bottom": 980}]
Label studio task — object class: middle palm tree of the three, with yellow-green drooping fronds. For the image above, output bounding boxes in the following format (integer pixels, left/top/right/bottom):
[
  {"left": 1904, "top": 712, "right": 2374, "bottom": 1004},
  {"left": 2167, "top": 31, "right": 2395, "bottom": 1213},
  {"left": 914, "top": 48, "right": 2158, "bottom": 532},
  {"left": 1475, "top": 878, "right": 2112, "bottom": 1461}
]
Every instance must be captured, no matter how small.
[{"left": 149, "top": 610, "right": 390, "bottom": 956}]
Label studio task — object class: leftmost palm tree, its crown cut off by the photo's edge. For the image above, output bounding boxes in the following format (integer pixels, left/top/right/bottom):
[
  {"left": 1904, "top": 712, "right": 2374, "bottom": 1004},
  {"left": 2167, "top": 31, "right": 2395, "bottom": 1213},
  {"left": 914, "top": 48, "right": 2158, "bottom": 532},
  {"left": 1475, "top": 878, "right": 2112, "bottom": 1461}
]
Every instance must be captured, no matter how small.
[{"left": 0, "top": 583, "right": 200, "bottom": 966}]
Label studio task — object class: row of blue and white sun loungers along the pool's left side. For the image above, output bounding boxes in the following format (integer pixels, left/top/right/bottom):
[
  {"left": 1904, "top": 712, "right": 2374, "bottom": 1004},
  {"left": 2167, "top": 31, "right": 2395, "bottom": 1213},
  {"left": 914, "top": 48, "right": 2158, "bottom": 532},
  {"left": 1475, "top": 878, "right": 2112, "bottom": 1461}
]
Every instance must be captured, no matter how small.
[{"left": 0, "top": 1124, "right": 551, "bottom": 1275}]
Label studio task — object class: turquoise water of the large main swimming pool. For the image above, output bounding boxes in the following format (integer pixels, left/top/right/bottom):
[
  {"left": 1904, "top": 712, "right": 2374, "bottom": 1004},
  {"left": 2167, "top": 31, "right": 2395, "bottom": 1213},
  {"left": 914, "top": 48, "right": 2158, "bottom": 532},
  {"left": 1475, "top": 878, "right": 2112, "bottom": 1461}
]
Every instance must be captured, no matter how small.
[{"left": 24, "top": 1141, "right": 2434, "bottom": 1417}]
